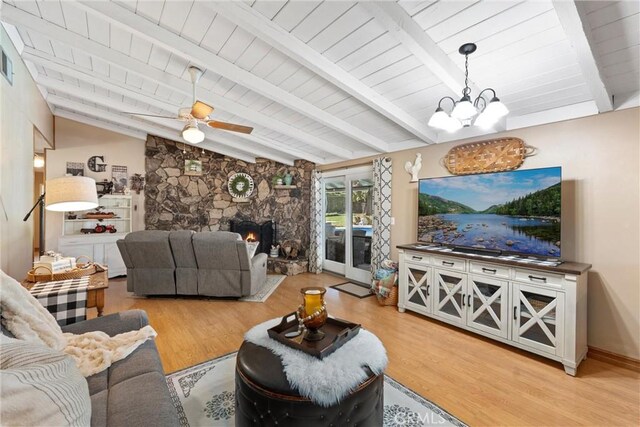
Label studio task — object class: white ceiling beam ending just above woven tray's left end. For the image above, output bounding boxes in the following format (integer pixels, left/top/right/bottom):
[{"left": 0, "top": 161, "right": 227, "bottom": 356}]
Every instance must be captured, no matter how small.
[{"left": 207, "top": 2, "right": 437, "bottom": 143}]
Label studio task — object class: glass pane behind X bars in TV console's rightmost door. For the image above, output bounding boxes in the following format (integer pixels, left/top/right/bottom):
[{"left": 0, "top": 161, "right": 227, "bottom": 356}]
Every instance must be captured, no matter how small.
[{"left": 520, "top": 291, "right": 556, "bottom": 347}]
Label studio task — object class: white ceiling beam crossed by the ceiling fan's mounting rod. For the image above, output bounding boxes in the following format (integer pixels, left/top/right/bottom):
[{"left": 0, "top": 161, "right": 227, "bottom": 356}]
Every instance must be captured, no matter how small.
[{"left": 2, "top": 3, "right": 354, "bottom": 159}]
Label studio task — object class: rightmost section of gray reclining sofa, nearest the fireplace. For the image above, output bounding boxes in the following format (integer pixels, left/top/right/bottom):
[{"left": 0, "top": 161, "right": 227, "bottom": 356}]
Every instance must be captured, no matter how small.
[{"left": 192, "top": 231, "right": 267, "bottom": 297}]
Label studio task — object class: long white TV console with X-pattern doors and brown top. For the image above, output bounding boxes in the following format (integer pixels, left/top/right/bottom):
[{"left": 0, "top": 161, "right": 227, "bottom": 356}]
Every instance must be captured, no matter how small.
[{"left": 398, "top": 244, "right": 591, "bottom": 376}]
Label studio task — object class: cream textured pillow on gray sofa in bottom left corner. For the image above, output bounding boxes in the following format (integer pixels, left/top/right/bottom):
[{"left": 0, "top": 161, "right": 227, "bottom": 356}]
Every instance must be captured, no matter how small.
[{"left": 0, "top": 336, "right": 91, "bottom": 426}]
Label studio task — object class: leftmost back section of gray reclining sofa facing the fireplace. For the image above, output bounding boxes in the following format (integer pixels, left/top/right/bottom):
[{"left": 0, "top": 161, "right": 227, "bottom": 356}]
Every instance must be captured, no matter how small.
[{"left": 117, "top": 230, "right": 176, "bottom": 295}]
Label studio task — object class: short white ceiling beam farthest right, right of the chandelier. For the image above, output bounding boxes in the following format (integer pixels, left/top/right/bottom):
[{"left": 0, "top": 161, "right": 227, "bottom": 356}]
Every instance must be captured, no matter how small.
[{"left": 553, "top": 0, "right": 613, "bottom": 113}]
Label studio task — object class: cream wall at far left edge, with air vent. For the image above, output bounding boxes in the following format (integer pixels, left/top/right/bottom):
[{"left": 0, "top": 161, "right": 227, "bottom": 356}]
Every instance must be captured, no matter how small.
[{"left": 0, "top": 26, "right": 53, "bottom": 279}]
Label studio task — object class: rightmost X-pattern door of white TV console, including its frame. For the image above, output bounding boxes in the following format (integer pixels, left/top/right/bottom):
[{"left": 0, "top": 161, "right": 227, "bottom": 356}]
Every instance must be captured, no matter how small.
[{"left": 513, "top": 283, "right": 564, "bottom": 356}]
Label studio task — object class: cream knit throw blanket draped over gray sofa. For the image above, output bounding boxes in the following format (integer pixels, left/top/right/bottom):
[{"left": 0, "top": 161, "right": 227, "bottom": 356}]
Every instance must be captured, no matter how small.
[{"left": 0, "top": 270, "right": 157, "bottom": 377}]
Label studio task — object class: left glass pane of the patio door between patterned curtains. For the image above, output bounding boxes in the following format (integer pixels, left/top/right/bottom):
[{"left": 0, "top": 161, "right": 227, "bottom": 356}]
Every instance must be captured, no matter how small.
[{"left": 324, "top": 176, "right": 346, "bottom": 263}]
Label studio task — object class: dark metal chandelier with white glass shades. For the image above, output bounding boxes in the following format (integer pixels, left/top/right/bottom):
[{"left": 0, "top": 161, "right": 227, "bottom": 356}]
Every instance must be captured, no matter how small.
[{"left": 428, "top": 43, "right": 509, "bottom": 132}]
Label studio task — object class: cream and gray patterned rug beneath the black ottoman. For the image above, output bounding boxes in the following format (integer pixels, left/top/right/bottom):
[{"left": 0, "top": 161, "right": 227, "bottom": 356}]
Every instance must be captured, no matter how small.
[{"left": 167, "top": 352, "right": 465, "bottom": 427}]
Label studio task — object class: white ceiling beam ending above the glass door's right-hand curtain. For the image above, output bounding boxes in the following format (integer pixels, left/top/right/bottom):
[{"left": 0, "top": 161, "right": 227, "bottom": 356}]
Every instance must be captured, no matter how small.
[{"left": 76, "top": 1, "right": 389, "bottom": 152}]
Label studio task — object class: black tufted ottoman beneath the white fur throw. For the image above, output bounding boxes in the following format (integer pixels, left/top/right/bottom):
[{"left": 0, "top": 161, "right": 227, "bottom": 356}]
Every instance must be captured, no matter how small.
[{"left": 236, "top": 341, "right": 384, "bottom": 427}]
